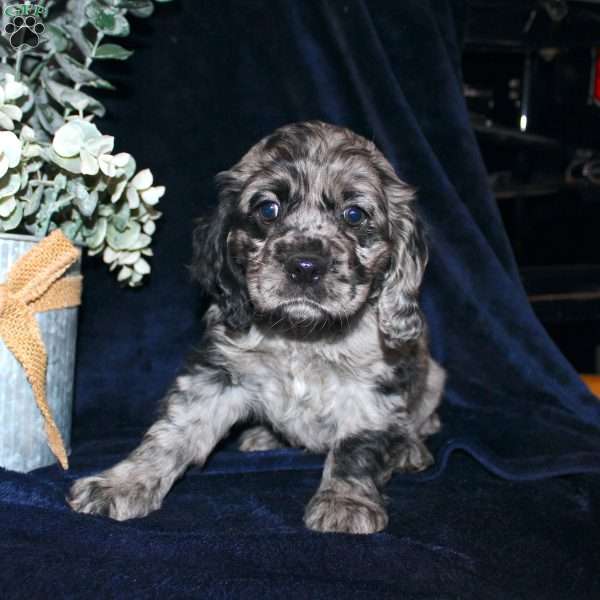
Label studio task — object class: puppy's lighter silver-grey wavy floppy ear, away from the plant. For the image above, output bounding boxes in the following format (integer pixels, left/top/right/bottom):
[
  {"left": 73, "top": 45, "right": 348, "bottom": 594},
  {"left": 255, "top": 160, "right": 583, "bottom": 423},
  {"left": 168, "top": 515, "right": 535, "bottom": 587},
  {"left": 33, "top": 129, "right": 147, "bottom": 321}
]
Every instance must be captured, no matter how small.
[{"left": 378, "top": 173, "right": 427, "bottom": 348}]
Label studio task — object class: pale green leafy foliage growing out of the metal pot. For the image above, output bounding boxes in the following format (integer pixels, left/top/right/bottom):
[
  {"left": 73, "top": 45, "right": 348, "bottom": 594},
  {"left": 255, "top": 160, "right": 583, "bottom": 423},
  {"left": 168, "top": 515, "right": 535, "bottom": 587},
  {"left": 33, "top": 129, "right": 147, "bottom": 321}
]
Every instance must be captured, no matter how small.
[{"left": 0, "top": 0, "right": 170, "bottom": 286}]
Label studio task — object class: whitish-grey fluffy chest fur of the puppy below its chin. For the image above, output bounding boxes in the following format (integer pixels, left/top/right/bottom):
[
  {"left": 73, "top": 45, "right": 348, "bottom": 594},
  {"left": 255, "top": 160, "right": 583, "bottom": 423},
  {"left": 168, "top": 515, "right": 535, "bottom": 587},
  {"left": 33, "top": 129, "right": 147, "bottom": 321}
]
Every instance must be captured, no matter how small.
[{"left": 232, "top": 324, "right": 389, "bottom": 452}]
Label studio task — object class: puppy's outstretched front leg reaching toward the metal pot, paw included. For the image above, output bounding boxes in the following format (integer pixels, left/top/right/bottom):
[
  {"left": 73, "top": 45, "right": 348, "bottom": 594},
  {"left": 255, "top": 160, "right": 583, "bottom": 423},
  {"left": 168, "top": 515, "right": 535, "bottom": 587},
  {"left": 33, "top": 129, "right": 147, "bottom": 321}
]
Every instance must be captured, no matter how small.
[{"left": 68, "top": 376, "right": 249, "bottom": 521}]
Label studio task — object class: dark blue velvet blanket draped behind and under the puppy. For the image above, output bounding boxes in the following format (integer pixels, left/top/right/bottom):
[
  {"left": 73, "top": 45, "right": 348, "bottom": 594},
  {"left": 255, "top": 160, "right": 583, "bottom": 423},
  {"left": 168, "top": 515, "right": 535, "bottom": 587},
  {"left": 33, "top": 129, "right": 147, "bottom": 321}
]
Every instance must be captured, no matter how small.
[{"left": 0, "top": 0, "right": 600, "bottom": 600}]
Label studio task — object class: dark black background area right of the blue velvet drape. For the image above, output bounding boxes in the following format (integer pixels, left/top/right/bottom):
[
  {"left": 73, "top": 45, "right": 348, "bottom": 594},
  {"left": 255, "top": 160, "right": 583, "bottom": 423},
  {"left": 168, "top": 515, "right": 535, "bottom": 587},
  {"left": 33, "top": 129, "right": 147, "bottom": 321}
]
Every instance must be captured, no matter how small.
[{"left": 463, "top": 0, "right": 600, "bottom": 373}]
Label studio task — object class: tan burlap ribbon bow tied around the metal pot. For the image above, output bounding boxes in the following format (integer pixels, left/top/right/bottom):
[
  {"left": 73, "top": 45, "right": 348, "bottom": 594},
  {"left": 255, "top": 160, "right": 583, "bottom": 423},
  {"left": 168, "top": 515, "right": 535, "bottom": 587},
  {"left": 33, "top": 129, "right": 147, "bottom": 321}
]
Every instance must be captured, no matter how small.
[{"left": 0, "top": 229, "right": 81, "bottom": 469}]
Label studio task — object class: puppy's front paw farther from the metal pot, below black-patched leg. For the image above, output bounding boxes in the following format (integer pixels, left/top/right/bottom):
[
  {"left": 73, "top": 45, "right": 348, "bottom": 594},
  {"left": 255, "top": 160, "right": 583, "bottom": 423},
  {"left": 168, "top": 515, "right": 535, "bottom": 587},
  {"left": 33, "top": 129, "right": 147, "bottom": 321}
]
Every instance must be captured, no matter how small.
[{"left": 304, "top": 490, "right": 388, "bottom": 534}]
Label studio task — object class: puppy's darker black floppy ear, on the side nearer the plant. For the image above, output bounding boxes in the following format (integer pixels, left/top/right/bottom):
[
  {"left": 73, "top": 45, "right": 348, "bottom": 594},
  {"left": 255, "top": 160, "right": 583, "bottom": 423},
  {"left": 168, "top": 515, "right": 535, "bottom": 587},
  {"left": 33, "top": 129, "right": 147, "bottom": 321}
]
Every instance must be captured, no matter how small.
[{"left": 190, "top": 171, "right": 253, "bottom": 329}]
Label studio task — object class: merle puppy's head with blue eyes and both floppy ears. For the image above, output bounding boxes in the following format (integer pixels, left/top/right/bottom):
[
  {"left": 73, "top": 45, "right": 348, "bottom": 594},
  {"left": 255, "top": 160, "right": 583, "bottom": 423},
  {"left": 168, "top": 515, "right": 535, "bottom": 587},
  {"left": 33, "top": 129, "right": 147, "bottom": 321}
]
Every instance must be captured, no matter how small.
[{"left": 192, "top": 122, "right": 427, "bottom": 347}]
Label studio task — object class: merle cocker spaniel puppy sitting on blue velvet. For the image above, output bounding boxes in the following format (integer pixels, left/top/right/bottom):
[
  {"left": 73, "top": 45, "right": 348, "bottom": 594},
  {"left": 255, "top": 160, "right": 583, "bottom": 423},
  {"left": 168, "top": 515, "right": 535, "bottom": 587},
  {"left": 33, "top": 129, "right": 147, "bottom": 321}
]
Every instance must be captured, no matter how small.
[{"left": 69, "top": 122, "right": 445, "bottom": 533}]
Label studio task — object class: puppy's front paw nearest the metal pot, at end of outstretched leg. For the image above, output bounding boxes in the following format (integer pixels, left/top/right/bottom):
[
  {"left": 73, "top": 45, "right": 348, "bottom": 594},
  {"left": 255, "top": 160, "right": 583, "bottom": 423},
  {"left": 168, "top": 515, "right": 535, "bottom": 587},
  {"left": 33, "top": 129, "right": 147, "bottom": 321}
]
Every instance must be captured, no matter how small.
[{"left": 67, "top": 474, "right": 162, "bottom": 521}]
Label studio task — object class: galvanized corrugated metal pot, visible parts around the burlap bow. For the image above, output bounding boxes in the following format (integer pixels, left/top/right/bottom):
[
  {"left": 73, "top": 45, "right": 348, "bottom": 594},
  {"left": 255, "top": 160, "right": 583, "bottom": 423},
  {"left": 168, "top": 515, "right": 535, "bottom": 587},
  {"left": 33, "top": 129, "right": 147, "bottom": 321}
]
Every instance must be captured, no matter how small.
[{"left": 0, "top": 234, "right": 81, "bottom": 472}]
